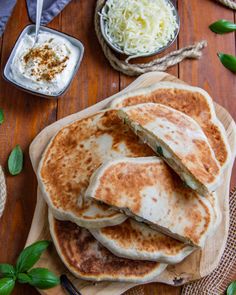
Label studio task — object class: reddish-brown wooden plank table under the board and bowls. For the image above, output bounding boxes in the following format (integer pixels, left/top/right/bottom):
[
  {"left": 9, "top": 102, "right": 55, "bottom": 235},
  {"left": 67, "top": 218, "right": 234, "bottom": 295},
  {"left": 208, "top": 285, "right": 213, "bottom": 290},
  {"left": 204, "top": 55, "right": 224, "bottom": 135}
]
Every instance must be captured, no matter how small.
[{"left": 0, "top": 0, "right": 236, "bottom": 295}]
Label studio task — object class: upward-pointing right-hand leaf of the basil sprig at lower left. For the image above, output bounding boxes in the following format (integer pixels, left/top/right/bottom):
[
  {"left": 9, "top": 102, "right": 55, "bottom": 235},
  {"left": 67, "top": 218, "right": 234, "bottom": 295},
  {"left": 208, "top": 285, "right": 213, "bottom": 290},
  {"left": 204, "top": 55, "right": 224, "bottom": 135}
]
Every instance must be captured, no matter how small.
[{"left": 16, "top": 241, "right": 50, "bottom": 273}]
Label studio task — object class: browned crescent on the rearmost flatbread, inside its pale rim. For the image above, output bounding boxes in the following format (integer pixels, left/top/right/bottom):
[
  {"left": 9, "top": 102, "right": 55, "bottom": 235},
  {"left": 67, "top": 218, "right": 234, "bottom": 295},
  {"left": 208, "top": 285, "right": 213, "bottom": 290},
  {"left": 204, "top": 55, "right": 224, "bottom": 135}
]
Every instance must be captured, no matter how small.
[{"left": 117, "top": 88, "right": 228, "bottom": 165}]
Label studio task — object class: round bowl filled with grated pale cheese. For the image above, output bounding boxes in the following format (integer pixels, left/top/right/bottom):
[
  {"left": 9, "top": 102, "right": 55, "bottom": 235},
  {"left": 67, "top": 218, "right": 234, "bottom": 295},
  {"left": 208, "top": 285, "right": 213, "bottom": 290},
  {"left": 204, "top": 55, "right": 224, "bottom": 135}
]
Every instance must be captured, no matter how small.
[{"left": 101, "top": 0, "right": 179, "bottom": 57}]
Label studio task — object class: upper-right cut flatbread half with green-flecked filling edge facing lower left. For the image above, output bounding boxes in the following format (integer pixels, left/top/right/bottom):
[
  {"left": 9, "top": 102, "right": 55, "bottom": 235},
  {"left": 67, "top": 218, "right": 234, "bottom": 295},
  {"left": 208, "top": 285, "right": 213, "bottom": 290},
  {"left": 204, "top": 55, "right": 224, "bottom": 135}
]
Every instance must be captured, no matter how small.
[{"left": 118, "top": 103, "right": 221, "bottom": 195}]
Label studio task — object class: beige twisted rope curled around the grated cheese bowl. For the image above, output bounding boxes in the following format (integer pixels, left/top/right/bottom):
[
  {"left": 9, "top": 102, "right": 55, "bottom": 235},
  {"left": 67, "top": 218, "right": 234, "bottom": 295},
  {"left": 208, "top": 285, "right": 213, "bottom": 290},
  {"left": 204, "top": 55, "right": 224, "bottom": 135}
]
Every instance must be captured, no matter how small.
[{"left": 94, "top": 0, "right": 207, "bottom": 76}]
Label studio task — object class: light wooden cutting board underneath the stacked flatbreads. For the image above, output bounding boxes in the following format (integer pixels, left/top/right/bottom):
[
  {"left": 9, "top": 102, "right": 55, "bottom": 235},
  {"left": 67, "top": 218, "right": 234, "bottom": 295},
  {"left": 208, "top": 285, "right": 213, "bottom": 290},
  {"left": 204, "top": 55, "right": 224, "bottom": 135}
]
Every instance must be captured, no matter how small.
[{"left": 26, "top": 72, "right": 236, "bottom": 295}]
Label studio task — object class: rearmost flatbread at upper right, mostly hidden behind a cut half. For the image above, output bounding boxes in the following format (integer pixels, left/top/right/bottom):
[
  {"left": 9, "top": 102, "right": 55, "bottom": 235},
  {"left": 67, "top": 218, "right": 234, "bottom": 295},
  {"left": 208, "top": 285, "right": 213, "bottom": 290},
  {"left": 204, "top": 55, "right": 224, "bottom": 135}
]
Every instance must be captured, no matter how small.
[{"left": 111, "top": 82, "right": 231, "bottom": 170}]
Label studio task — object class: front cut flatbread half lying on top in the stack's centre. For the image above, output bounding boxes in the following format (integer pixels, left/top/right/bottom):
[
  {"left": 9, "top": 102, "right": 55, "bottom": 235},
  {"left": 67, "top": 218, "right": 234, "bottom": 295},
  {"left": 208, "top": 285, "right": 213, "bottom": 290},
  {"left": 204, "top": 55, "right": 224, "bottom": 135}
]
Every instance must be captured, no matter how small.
[{"left": 85, "top": 157, "right": 220, "bottom": 247}]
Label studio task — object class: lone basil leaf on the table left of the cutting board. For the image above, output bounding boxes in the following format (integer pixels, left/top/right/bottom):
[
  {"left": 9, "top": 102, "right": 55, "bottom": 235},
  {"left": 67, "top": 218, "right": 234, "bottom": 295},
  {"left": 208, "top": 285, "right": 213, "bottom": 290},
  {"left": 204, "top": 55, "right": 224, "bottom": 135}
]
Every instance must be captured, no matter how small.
[{"left": 8, "top": 145, "right": 23, "bottom": 175}]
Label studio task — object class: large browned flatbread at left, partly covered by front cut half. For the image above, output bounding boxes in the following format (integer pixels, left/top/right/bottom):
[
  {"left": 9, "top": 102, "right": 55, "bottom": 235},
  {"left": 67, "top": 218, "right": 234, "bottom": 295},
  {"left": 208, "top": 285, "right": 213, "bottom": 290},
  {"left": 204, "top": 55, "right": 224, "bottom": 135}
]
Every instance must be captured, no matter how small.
[{"left": 37, "top": 110, "right": 154, "bottom": 228}]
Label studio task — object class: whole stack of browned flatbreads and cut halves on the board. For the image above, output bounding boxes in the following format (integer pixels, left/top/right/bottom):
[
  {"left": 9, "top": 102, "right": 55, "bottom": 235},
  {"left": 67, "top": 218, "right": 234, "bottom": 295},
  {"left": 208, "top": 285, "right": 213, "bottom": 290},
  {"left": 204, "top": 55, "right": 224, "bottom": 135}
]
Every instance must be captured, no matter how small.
[{"left": 38, "top": 82, "right": 230, "bottom": 282}]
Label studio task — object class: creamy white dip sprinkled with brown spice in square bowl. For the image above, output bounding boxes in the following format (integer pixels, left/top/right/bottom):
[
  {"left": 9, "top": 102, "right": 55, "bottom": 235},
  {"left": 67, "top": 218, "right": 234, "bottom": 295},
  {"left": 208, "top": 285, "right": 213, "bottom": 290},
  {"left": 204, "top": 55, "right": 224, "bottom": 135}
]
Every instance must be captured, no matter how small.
[{"left": 11, "top": 32, "right": 79, "bottom": 95}]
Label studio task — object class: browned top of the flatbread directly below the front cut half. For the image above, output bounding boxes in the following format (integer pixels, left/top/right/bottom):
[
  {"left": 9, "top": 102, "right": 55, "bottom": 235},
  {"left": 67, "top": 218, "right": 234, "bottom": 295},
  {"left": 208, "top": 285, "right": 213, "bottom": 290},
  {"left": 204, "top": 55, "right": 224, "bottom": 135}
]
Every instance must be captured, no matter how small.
[{"left": 101, "top": 219, "right": 185, "bottom": 255}]
